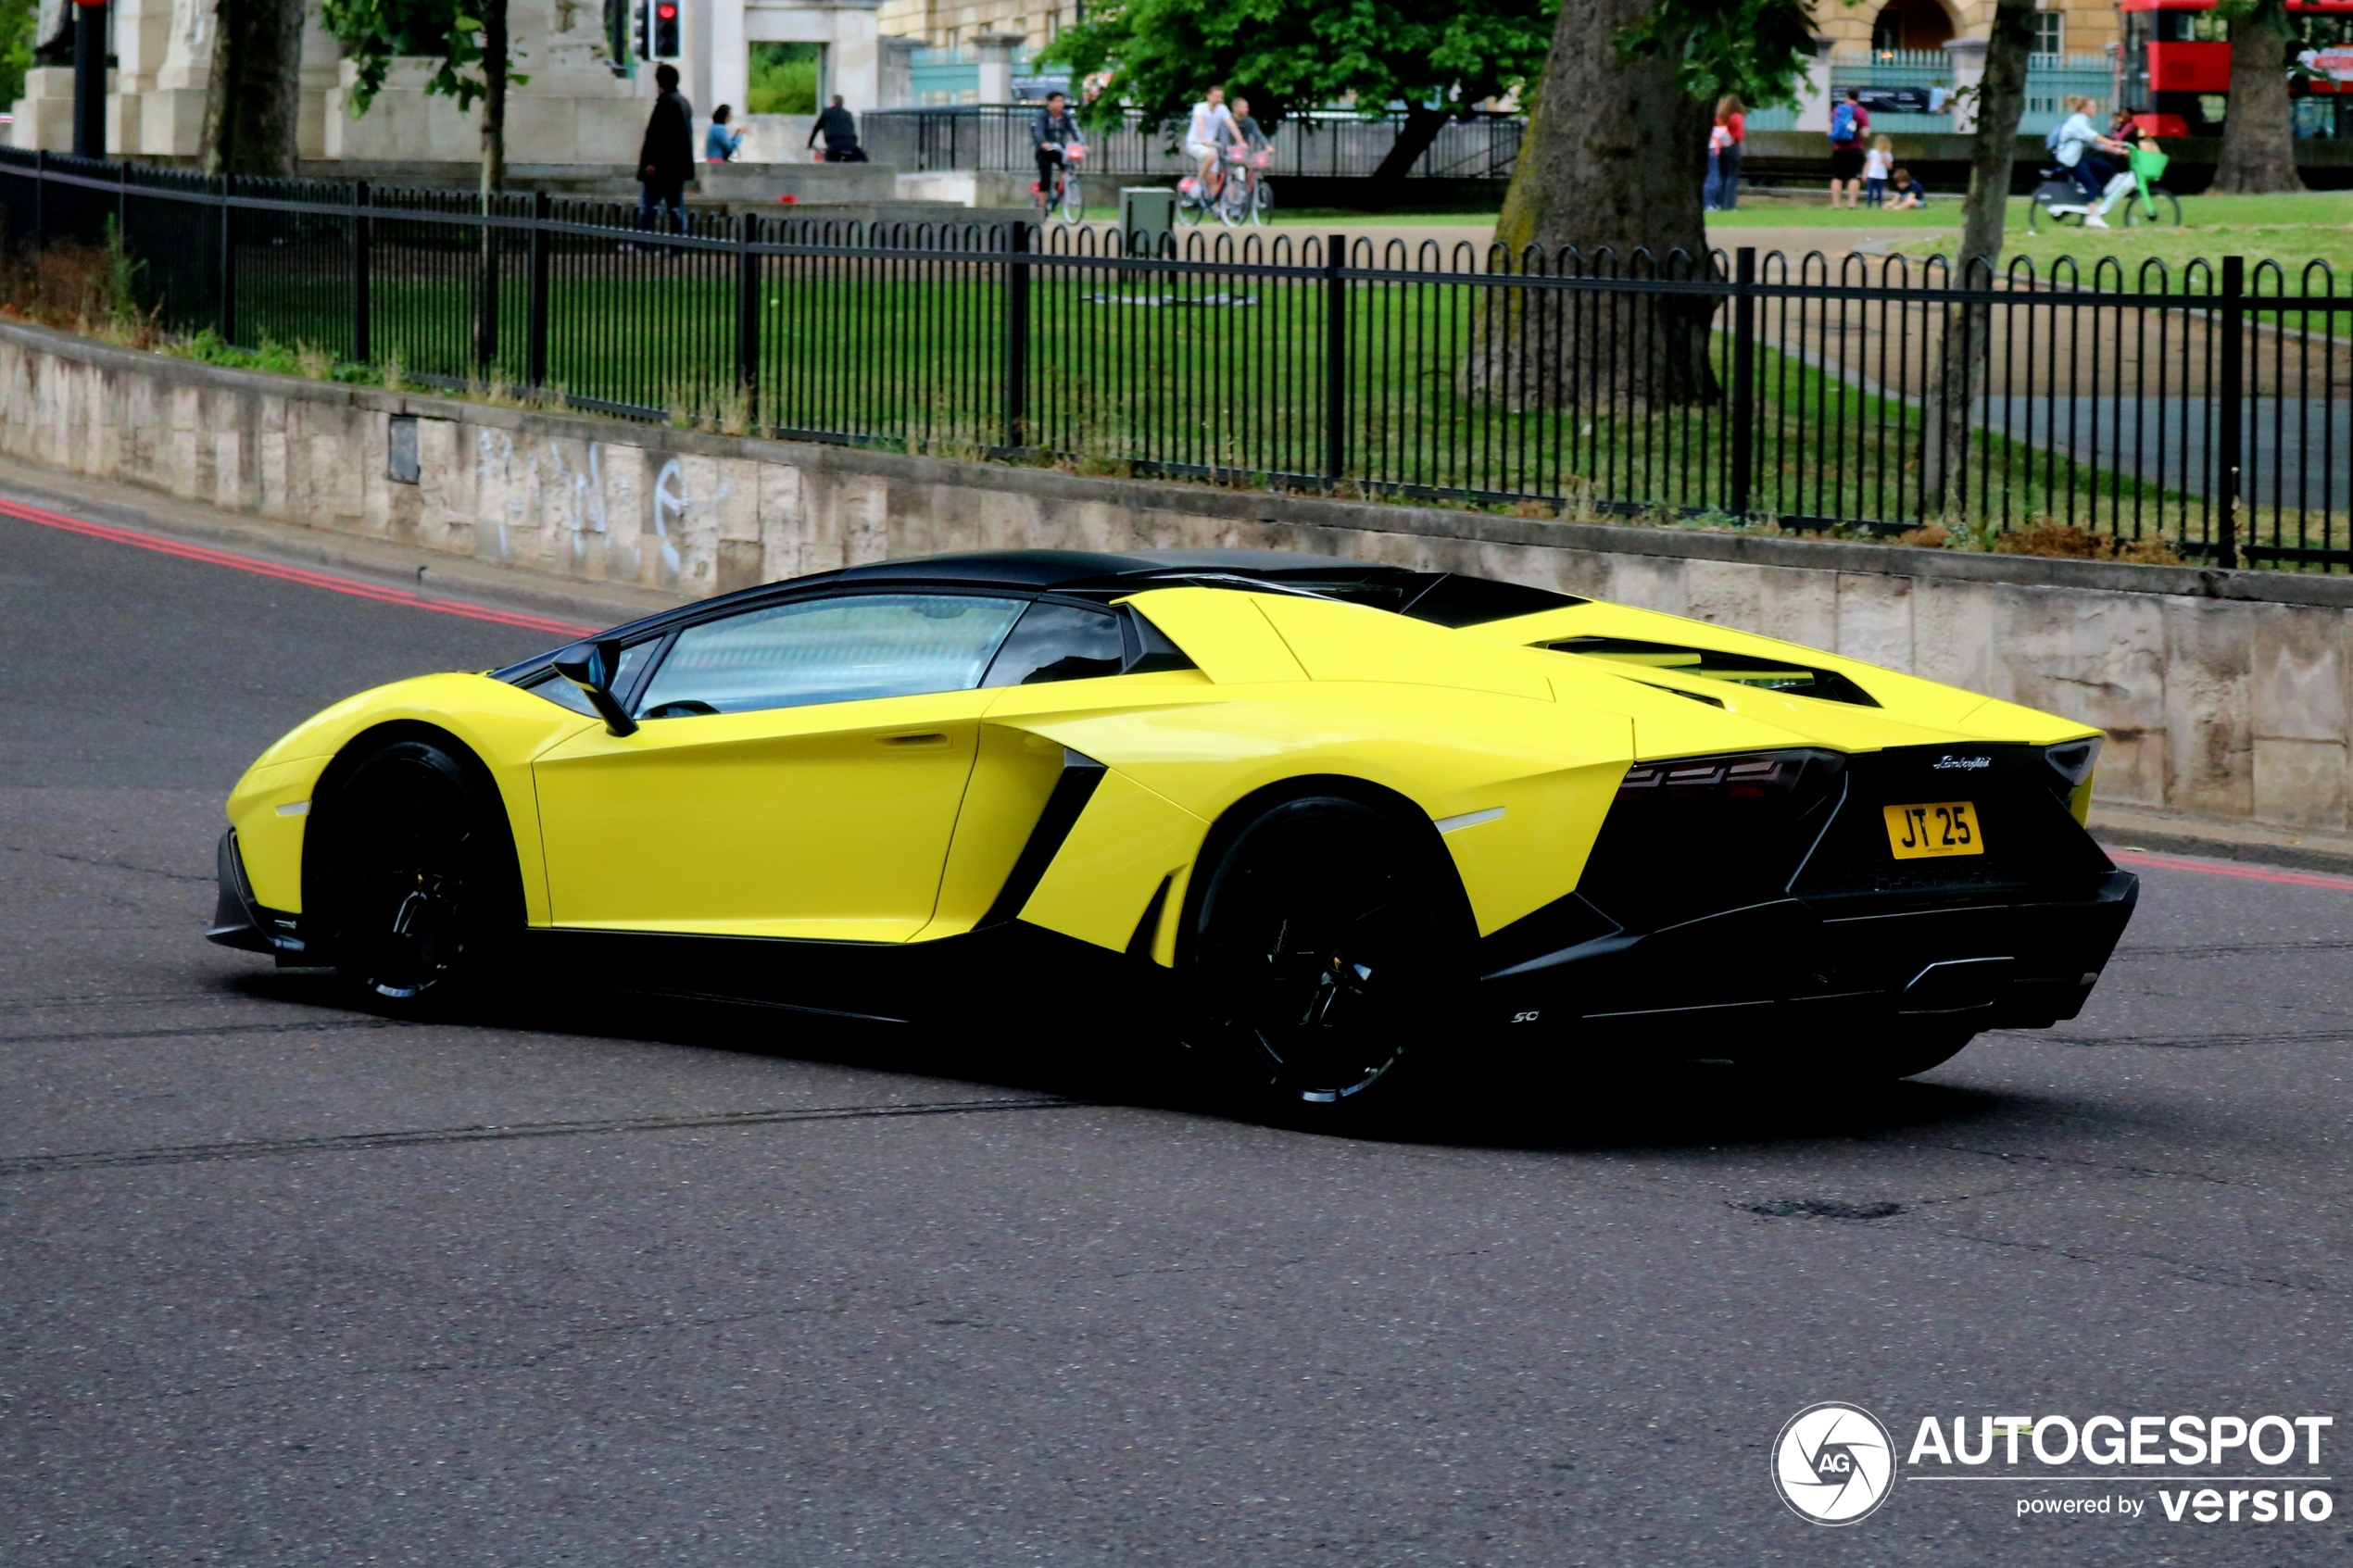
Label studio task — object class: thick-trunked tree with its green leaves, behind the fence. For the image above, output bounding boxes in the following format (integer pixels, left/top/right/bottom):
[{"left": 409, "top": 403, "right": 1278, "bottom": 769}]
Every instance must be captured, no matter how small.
[{"left": 1461, "top": 0, "right": 1814, "bottom": 407}]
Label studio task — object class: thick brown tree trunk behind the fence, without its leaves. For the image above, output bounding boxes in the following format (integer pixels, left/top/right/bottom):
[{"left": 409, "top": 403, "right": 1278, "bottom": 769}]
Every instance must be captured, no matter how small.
[{"left": 1459, "top": 0, "right": 1720, "bottom": 414}]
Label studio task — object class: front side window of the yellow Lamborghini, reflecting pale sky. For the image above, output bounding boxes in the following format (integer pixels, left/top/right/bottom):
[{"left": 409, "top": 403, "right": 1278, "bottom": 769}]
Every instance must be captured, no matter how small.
[{"left": 637, "top": 593, "right": 1026, "bottom": 720}]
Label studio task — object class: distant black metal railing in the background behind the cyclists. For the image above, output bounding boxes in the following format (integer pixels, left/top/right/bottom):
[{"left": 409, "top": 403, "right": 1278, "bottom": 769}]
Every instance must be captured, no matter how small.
[{"left": 859, "top": 106, "right": 1525, "bottom": 181}]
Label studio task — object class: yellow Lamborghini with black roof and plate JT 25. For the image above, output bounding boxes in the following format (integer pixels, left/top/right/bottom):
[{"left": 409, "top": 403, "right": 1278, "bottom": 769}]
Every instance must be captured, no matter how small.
[{"left": 209, "top": 550, "right": 2136, "bottom": 1105}]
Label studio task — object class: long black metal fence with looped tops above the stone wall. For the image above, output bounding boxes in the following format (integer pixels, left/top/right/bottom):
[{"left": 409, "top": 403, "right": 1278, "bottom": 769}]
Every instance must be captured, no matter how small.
[{"left": 0, "top": 153, "right": 2353, "bottom": 569}]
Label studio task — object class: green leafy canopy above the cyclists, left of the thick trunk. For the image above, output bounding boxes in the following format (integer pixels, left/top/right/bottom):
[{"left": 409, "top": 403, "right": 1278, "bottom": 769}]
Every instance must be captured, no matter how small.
[{"left": 1045, "top": 0, "right": 1557, "bottom": 199}]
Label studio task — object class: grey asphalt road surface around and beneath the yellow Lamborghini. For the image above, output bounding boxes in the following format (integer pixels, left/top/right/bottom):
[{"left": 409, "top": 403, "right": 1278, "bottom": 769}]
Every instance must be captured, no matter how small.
[{"left": 0, "top": 483, "right": 2353, "bottom": 1568}]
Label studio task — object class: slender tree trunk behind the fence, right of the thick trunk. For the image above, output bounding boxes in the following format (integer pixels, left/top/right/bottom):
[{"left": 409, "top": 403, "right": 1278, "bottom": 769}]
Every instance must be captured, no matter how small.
[{"left": 1920, "top": 0, "right": 2035, "bottom": 517}]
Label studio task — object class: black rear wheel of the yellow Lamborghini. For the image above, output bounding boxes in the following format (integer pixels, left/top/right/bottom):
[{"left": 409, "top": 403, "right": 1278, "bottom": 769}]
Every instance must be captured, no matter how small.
[{"left": 1179, "top": 795, "right": 1468, "bottom": 1126}]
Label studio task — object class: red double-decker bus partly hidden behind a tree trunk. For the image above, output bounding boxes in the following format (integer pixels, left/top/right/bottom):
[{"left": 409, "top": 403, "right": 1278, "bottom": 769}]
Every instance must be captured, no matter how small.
[{"left": 2118, "top": 0, "right": 2353, "bottom": 139}]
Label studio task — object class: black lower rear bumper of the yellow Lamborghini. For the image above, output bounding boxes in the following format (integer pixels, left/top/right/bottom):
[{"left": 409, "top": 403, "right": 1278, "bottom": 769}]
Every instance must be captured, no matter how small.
[{"left": 1478, "top": 872, "right": 2139, "bottom": 1058}]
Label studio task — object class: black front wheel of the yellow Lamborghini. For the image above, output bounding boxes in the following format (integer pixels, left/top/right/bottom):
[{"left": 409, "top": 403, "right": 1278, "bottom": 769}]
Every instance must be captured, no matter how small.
[{"left": 320, "top": 741, "right": 522, "bottom": 1013}]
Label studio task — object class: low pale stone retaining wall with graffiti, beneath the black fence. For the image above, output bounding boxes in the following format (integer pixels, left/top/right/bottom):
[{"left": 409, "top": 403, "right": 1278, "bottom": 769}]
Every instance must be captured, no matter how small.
[{"left": 13, "top": 324, "right": 2353, "bottom": 830}]
